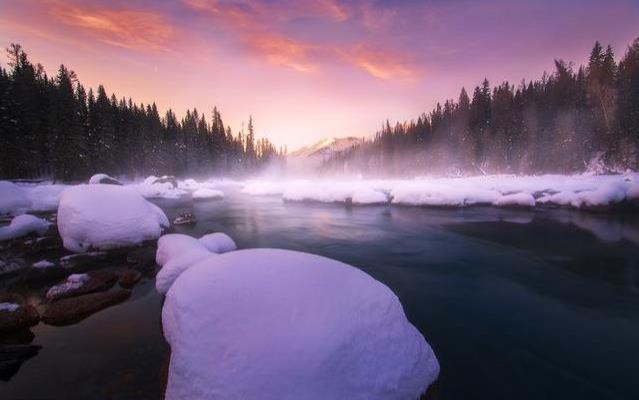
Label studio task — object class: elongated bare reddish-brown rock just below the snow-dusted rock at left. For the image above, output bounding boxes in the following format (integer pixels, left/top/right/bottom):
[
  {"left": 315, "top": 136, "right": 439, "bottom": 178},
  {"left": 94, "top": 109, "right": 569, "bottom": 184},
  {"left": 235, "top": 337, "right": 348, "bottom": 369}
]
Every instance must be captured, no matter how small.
[{"left": 42, "top": 289, "right": 131, "bottom": 325}]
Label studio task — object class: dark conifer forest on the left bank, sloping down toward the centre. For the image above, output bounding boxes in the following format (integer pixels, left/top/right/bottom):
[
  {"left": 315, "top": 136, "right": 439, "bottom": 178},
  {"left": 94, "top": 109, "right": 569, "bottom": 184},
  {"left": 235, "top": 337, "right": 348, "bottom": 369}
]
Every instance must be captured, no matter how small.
[{"left": 0, "top": 44, "right": 284, "bottom": 181}]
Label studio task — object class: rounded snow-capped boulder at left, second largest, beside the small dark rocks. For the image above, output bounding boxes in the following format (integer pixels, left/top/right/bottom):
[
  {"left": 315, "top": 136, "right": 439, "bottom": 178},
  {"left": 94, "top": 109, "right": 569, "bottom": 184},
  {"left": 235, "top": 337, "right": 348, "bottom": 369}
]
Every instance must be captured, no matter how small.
[{"left": 58, "top": 185, "right": 169, "bottom": 253}]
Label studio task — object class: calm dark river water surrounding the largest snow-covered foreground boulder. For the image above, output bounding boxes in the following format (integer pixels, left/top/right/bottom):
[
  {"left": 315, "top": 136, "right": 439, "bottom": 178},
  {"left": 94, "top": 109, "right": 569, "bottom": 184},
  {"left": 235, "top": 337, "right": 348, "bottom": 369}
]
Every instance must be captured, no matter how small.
[{"left": 0, "top": 190, "right": 639, "bottom": 400}]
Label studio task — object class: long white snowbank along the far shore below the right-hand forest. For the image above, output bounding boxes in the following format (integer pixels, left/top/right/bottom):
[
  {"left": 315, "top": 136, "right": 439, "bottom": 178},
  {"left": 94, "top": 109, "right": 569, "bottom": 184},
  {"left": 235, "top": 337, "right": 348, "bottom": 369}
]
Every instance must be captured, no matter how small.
[{"left": 242, "top": 173, "right": 639, "bottom": 208}]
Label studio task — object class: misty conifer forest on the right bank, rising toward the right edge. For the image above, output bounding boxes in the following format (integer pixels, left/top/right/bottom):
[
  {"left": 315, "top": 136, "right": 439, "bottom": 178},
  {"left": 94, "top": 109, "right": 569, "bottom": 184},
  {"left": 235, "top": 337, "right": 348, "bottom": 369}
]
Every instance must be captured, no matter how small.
[{"left": 322, "top": 39, "right": 639, "bottom": 175}]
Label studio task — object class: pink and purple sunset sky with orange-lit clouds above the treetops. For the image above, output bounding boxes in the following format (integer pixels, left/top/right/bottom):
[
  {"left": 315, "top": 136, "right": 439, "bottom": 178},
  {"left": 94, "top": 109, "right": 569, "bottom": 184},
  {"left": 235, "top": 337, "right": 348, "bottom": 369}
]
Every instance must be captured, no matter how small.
[{"left": 0, "top": 0, "right": 639, "bottom": 150}]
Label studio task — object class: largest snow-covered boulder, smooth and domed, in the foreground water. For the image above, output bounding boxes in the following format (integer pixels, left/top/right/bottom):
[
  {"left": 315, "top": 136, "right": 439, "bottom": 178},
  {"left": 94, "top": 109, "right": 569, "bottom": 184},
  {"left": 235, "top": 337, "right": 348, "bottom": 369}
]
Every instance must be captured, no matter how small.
[{"left": 162, "top": 249, "right": 439, "bottom": 400}]
